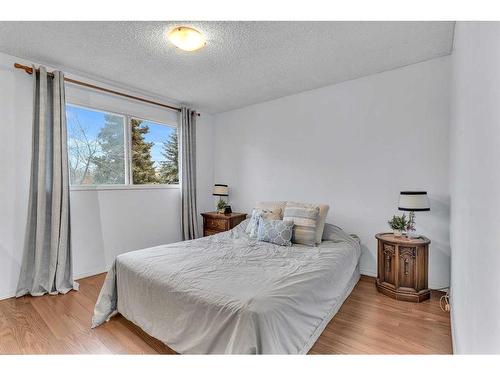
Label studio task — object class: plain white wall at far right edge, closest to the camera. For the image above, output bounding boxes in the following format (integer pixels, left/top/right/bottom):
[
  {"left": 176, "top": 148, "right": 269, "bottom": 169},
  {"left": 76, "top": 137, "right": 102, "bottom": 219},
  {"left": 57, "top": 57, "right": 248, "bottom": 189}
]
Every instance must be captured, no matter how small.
[{"left": 450, "top": 22, "right": 500, "bottom": 354}]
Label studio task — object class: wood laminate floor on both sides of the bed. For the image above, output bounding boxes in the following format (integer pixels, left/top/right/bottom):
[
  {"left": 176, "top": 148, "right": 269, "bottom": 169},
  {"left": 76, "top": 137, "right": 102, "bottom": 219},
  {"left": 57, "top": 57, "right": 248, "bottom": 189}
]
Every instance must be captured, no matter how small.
[{"left": 0, "top": 274, "right": 451, "bottom": 354}]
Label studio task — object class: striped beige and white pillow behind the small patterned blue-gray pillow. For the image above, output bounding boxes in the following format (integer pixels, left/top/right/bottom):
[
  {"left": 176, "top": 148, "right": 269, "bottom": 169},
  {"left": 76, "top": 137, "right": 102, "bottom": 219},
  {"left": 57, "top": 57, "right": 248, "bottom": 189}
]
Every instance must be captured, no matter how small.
[{"left": 283, "top": 202, "right": 319, "bottom": 246}]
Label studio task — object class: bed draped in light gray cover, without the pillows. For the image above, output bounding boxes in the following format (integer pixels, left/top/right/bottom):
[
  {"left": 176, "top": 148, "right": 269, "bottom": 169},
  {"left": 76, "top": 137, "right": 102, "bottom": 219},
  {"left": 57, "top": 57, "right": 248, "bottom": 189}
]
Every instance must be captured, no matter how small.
[{"left": 92, "top": 219, "right": 361, "bottom": 354}]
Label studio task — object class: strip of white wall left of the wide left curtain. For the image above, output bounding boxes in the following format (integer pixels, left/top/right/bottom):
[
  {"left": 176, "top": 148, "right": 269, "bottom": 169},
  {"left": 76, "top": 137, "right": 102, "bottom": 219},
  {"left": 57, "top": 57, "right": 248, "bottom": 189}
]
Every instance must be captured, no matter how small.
[{"left": 0, "top": 54, "right": 32, "bottom": 299}]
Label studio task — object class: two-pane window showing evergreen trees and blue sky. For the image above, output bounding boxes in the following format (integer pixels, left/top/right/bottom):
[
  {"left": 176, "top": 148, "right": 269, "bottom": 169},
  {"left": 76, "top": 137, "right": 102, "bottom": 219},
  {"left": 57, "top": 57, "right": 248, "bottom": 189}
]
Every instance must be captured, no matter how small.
[{"left": 66, "top": 104, "right": 179, "bottom": 186}]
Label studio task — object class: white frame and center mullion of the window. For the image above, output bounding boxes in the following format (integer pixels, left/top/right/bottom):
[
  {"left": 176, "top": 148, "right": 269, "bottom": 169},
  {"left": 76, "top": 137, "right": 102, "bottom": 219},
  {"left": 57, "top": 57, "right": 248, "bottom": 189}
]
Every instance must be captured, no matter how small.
[{"left": 65, "top": 101, "right": 180, "bottom": 191}]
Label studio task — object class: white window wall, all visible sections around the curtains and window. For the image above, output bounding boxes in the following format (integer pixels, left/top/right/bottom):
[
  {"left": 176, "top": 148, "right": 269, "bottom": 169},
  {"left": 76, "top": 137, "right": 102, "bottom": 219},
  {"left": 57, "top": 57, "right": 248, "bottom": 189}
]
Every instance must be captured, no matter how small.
[{"left": 0, "top": 54, "right": 213, "bottom": 299}]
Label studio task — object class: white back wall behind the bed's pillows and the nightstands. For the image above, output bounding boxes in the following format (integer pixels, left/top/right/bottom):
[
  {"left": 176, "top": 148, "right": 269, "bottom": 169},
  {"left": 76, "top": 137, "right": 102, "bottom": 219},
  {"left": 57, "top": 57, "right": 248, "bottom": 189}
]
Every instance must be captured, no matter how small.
[{"left": 214, "top": 57, "right": 450, "bottom": 287}]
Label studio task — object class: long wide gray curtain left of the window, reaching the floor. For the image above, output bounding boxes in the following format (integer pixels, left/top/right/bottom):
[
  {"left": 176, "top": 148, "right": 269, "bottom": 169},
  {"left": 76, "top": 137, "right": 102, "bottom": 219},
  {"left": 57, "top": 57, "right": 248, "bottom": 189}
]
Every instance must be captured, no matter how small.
[{"left": 16, "top": 67, "right": 78, "bottom": 297}]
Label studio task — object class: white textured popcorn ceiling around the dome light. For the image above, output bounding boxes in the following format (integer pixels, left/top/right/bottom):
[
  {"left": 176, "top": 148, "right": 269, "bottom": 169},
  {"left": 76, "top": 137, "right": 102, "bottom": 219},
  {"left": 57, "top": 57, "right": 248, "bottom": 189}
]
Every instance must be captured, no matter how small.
[{"left": 0, "top": 22, "right": 454, "bottom": 113}]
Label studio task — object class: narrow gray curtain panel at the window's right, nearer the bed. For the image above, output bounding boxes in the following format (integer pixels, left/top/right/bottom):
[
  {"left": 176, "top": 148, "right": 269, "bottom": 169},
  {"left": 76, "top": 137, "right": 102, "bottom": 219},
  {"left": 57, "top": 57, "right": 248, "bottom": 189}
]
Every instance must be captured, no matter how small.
[{"left": 179, "top": 107, "right": 198, "bottom": 240}]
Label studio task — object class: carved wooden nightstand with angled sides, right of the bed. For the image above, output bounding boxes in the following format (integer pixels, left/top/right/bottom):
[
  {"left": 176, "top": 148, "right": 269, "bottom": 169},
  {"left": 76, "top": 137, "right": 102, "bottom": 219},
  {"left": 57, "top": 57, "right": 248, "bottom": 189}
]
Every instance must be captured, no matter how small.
[{"left": 375, "top": 233, "right": 431, "bottom": 302}]
